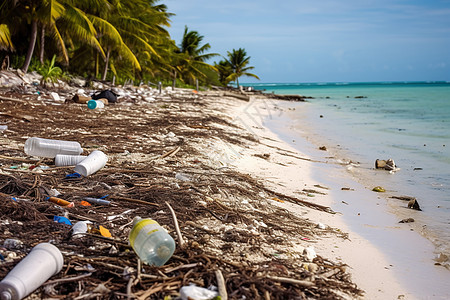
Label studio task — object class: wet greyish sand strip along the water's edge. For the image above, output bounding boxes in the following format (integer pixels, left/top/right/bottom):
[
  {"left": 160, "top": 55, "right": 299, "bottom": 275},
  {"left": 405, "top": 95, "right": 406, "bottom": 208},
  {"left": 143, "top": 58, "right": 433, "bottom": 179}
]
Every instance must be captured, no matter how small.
[{"left": 250, "top": 95, "right": 450, "bottom": 299}]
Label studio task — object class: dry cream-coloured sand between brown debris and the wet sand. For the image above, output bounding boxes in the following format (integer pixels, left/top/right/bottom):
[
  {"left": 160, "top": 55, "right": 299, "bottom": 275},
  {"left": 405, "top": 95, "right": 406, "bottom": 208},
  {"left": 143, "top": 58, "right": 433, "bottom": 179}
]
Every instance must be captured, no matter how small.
[{"left": 219, "top": 100, "right": 415, "bottom": 299}]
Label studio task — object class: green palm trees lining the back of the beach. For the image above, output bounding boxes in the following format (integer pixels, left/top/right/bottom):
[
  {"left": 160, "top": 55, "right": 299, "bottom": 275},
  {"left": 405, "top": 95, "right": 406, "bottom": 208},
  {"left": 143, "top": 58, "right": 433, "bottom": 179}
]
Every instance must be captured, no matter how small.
[{"left": 0, "top": 0, "right": 259, "bottom": 86}]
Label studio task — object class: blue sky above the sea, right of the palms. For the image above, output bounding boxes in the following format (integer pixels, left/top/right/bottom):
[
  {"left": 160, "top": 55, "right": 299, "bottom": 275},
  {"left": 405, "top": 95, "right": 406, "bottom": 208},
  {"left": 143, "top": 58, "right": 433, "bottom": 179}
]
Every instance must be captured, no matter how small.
[{"left": 161, "top": 0, "right": 450, "bottom": 82}]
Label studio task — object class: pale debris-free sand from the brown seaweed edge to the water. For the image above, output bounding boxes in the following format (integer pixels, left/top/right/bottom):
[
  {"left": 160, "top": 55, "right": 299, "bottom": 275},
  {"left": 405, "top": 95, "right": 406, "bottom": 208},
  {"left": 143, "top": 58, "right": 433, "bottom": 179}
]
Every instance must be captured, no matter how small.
[{"left": 214, "top": 95, "right": 450, "bottom": 299}]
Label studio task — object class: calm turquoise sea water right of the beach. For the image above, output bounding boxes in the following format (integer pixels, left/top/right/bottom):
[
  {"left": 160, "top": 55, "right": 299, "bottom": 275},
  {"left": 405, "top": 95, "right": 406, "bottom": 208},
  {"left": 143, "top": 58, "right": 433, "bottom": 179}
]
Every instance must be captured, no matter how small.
[{"left": 246, "top": 82, "right": 450, "bottom": 262}]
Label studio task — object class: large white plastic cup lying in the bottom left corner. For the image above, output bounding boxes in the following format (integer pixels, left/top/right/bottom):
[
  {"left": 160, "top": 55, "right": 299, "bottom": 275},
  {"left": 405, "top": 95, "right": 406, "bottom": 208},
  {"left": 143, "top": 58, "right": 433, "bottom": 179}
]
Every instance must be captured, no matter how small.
[{"left": 0, "top": 243, "right": 64, "bottom": 300}]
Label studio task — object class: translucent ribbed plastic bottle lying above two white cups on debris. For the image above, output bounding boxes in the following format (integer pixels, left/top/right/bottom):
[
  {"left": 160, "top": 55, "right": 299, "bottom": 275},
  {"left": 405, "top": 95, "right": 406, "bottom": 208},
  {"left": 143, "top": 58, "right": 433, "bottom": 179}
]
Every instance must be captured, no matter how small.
[{"left": 24, "top": 137, "right": 83, "bottom": 158}]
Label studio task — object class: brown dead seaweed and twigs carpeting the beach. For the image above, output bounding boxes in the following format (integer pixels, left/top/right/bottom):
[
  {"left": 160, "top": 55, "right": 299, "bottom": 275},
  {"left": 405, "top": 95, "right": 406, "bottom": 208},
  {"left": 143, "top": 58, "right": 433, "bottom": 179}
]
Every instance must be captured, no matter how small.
[{"left": 0, "top": 88, "right": 362, "bottom": 299}]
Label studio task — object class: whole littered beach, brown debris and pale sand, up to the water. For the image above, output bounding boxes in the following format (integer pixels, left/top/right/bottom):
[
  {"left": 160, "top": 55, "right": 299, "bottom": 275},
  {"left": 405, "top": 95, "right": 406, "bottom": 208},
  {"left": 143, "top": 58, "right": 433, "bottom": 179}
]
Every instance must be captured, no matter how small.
[{"left": 0, "top": 77, "right": 449, "bottom": 299}]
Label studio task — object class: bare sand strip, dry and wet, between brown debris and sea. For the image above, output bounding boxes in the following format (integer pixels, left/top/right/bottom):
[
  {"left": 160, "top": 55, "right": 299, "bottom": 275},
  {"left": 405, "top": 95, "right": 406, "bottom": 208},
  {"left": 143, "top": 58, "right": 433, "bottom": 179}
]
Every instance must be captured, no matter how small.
[{"left": 225, "top": 97, "right": 450, "bottom": 299}]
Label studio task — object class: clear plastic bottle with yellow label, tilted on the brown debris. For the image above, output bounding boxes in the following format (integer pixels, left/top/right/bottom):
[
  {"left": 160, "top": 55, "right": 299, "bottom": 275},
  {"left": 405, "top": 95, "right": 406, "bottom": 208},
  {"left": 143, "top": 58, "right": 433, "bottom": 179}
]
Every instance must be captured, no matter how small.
[{"left": 129, "top": 217, "right": 175, "bottom": 267}]
